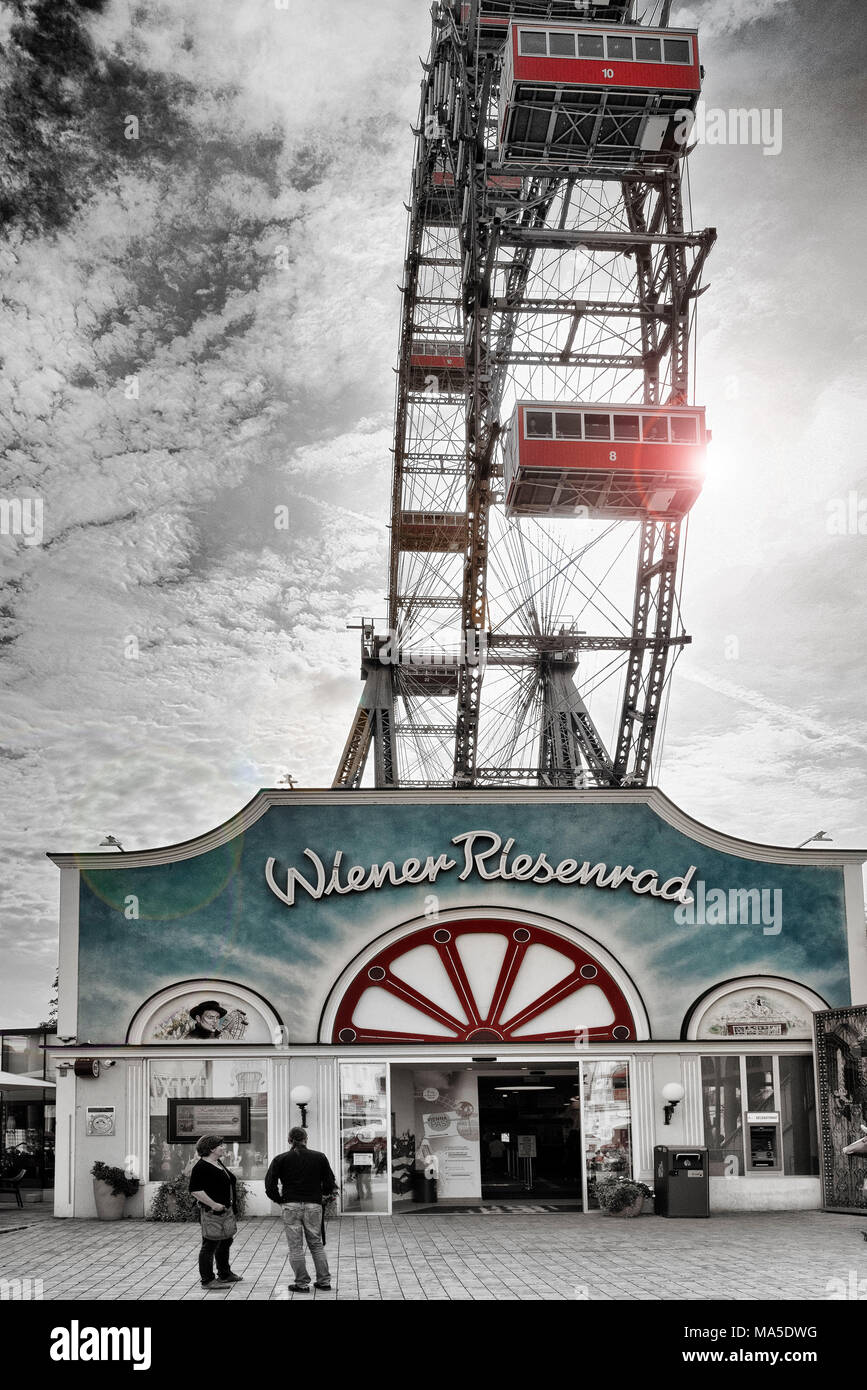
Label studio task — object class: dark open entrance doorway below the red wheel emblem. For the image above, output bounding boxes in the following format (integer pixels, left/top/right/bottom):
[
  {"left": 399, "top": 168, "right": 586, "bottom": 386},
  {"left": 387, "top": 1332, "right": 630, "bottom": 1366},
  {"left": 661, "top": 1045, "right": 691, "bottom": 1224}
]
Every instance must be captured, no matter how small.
[{"left": 478, "top": 1072, "right": 584, "bottom": 1207}]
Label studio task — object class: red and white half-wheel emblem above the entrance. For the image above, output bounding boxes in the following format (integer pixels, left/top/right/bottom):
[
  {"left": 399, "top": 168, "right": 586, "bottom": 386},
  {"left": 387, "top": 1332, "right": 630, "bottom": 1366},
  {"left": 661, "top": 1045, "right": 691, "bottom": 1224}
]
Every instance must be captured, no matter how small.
[{"left": 332, "top": 917, "right": 635, "bottom": 1044}]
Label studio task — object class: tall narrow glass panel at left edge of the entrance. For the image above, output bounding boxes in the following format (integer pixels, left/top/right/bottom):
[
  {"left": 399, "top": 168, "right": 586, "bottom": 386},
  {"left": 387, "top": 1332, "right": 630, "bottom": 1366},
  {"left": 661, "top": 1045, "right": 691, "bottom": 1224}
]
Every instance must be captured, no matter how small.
[{"left": 340, "top": 1062, "right": 389, "bottom": 1212}]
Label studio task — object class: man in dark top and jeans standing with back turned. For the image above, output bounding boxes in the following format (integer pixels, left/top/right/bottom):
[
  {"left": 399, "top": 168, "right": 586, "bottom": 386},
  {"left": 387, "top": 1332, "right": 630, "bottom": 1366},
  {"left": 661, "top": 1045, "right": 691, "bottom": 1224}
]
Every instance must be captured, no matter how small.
[{"left": 265, "top": 1126, "right": 338, "bottom": 1294}]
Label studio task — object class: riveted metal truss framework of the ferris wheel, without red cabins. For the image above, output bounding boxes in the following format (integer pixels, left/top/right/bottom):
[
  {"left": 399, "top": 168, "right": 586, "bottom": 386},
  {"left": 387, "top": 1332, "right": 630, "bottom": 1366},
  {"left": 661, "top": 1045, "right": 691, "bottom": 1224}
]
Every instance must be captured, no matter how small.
[{"left": 333, "top": 0, "right": 716, "bottom": 787}]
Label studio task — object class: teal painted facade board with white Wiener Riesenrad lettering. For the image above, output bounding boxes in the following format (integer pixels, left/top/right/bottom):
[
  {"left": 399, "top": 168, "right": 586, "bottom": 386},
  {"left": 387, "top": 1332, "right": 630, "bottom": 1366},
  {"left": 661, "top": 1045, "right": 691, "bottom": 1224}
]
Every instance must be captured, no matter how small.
[{"left": 54, "top": 790, "right": 867, "bottom": 1047}]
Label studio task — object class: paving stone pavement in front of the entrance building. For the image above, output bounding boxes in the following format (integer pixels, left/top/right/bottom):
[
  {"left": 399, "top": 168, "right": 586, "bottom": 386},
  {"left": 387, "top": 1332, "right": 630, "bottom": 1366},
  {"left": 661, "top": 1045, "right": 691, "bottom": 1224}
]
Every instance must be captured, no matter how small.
[{"left": 0, "top": 1208, "right": 867, "bottom": 1302}]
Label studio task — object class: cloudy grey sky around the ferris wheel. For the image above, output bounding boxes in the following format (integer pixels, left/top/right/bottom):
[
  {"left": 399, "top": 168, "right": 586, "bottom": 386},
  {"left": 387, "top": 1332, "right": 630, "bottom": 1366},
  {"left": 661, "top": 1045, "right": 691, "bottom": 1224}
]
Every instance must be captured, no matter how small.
[{"left": 0, "top": 0, "right": 867, "bottom": 1026}]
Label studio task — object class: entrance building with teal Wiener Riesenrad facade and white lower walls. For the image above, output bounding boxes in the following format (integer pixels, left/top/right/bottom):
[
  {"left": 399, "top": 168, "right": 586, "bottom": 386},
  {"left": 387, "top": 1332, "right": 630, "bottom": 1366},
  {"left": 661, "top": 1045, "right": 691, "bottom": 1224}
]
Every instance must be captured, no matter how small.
[{"left": 51, "top": 790, "right": 867, "bottom": 1216}]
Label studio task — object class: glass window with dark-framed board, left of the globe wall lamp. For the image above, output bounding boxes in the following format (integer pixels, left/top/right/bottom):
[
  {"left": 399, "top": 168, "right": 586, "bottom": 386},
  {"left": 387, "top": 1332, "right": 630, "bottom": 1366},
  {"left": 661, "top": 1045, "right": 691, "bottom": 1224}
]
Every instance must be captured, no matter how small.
[{"left": 147, "top": 1056, "right": 268, "bottom": 1183}]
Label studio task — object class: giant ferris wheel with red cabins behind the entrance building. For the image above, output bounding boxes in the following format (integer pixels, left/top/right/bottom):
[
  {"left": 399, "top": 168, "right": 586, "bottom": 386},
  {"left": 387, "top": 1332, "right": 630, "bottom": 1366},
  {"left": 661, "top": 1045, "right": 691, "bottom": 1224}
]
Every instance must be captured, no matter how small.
[{"left": 333, "top": 0, "right": 716, "bottom": 788}]
